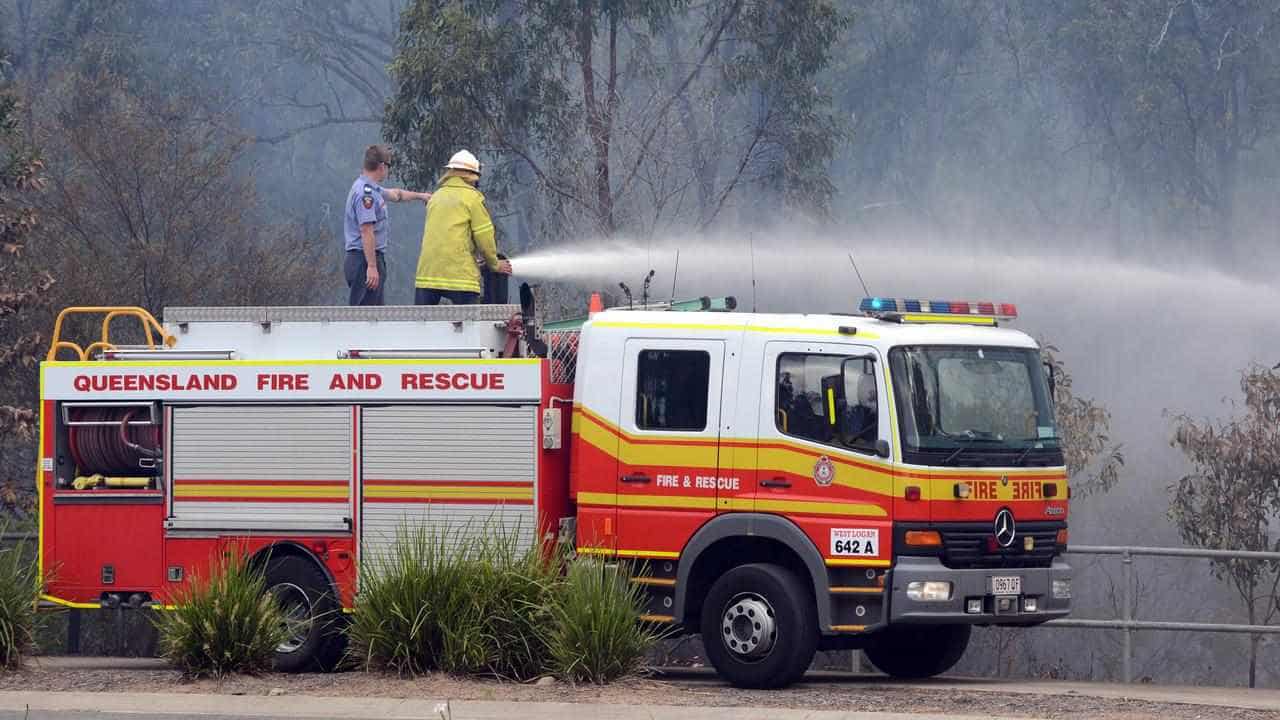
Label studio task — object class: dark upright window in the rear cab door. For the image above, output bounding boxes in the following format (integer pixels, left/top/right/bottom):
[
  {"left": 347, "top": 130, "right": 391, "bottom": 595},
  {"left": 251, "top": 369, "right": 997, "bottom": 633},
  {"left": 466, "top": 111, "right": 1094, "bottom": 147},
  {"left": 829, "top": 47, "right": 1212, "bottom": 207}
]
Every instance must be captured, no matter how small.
[{"left": 636, "top": 350, "right": 712, "bottom": 430}]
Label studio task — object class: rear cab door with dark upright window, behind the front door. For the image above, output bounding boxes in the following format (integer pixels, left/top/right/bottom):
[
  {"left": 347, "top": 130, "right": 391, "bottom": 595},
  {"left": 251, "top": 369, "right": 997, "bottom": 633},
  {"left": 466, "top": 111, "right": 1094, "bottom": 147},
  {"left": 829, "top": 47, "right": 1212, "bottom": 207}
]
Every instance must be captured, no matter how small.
[{"left": 617, "top": 338, "right": 724, "bottom": 557}]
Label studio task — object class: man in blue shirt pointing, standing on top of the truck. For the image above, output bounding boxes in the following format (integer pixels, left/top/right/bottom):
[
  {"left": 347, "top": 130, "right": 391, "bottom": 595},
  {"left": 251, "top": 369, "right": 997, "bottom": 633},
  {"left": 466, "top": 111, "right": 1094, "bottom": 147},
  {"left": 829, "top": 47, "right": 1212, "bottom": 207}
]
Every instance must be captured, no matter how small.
[{"left": 342, "top": 145, "right": 431, "bottom": 305}]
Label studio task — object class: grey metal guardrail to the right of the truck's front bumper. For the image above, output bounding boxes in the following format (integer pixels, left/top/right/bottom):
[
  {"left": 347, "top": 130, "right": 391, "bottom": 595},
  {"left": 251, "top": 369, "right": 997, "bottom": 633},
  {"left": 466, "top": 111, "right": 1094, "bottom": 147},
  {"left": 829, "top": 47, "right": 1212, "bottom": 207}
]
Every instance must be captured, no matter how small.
[{"left": 1044, "top": 544, "right": 1280, "bottom": 683}]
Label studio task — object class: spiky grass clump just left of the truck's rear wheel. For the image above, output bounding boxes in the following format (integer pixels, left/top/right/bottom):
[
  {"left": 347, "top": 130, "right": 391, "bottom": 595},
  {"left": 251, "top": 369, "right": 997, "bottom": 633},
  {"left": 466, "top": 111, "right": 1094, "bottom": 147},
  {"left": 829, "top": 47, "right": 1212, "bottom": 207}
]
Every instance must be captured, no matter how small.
[{"left": 156, "top": 553, "right": 288, "bottom": 676}]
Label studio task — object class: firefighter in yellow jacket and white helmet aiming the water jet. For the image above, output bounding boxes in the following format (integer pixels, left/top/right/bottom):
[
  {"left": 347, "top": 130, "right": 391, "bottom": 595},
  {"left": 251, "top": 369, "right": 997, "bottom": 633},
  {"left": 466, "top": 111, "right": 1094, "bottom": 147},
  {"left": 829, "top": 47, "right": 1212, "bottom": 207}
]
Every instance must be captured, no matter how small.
[{"left": 413, "top": 150, "right": 511, "bottom": 305}]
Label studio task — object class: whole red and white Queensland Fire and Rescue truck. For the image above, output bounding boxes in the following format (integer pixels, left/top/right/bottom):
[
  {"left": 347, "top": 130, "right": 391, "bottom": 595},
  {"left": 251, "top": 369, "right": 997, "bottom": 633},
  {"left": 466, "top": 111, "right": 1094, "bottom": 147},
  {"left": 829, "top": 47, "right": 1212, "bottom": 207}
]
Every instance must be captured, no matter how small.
[{"left": 36, "top": 293, "right": 1071, "bottom": 688}]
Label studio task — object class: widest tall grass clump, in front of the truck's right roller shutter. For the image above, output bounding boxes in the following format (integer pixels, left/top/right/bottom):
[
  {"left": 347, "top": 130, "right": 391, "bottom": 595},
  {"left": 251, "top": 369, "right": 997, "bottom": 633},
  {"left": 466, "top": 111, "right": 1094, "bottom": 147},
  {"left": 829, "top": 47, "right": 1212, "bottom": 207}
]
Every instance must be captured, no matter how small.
[{"left": 348, "top": 520, "right": 558, "bottom": 680}]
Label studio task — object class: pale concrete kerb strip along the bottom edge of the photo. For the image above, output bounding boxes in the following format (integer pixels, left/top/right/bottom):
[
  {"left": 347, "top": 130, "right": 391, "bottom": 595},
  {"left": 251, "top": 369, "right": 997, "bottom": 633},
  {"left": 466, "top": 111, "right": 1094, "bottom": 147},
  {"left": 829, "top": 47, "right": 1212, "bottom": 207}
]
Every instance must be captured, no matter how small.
[{"left": 0, "top": 692, "right": 1018, "bottom": 720}]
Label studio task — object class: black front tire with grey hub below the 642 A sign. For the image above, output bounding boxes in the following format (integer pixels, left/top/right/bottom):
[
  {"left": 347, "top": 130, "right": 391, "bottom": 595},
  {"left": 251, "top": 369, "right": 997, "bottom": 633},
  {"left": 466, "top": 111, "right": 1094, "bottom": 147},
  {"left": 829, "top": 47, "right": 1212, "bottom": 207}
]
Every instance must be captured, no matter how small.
[{"left": 700, "top": 564, "right": 818, "bottom": 688}]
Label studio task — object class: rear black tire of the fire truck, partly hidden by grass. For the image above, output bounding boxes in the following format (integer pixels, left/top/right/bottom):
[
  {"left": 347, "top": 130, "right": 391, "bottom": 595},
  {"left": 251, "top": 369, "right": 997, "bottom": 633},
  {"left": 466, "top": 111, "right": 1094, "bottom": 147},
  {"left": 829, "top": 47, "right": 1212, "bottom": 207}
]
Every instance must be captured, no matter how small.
[{"left": 265, "top": 555, "right": 347, "bottom": 673}]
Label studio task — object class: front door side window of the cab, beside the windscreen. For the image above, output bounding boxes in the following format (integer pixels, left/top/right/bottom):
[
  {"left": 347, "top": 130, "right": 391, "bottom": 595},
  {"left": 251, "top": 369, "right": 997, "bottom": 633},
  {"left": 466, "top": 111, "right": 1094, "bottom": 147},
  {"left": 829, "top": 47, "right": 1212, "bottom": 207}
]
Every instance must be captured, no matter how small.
[{"left": 773, "top": 352, "right": 879, "bottom": 452}]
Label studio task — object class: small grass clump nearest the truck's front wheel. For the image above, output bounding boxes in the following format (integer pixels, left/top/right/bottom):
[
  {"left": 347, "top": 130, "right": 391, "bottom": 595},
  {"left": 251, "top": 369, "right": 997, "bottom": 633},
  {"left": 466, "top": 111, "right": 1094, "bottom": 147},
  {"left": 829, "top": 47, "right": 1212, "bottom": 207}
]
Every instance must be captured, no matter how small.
[{"left": 547, "top": 556, "right": 662, "bottom": 683}]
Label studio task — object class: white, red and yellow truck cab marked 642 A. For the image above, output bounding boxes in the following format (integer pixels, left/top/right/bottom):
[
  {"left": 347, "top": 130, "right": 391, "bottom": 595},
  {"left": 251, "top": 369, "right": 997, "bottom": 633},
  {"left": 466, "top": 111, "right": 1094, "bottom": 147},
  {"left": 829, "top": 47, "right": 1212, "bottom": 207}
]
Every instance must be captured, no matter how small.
[{"left": 570, "top": 299, "right": 1071, "bottom": 687}]
